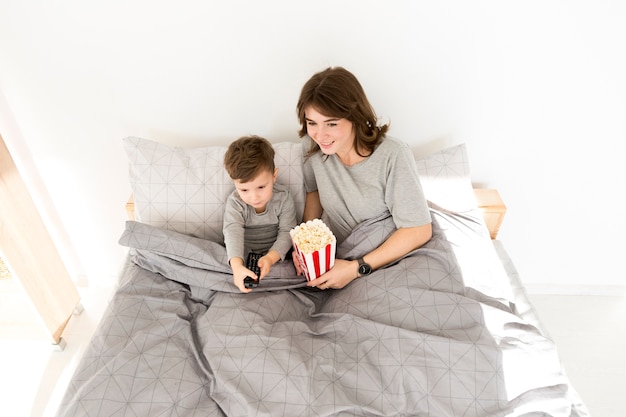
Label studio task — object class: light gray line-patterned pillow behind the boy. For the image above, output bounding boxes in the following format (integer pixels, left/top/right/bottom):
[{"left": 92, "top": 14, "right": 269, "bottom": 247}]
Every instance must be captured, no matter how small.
[{"left": 123, "top": 137, "right": 305, "bottom": 242}]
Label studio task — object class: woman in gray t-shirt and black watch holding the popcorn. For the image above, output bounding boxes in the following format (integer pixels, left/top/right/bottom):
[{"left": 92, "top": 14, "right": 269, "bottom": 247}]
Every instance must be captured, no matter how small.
[{"left": 295, "top": 67, "right": 432, "bottom": 289}]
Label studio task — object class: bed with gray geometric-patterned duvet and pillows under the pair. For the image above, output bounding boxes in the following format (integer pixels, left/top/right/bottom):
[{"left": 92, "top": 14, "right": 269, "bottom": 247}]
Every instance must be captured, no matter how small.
[{"left": 57, "top": 137, "right": 588, "bottom": 417}]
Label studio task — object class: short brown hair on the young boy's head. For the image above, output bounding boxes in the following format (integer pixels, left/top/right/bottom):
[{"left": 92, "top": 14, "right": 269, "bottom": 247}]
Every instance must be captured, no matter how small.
[{"left": 224, "top": 135, "right": 275, "bottom": 182}]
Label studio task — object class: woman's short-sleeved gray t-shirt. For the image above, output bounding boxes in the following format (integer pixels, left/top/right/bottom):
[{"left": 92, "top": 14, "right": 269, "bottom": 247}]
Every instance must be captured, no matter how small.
[{"left": 304, "top": 136, "right": 431, "bottom": 242}]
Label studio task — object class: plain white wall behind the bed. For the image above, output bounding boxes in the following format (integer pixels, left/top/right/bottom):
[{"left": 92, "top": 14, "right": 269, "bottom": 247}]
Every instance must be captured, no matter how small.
[{"left": 0, "top": 0, "right": 626, "bottom": 291}]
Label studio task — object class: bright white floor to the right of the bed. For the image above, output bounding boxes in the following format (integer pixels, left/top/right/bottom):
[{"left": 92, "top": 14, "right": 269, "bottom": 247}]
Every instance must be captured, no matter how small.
[{"left": 530, "top": 295, "right": 626, "bottom": 417}]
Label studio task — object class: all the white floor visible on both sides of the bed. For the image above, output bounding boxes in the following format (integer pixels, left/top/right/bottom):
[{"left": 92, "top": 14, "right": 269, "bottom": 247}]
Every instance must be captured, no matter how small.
[{"left": 0, "top": 279, "right": 626, "bottom": 417}]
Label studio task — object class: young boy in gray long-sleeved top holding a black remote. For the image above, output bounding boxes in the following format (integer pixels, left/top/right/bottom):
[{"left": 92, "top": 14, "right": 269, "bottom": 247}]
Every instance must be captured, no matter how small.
[{"left": 223, "top": 136, "right": 296, "bottom": 292}]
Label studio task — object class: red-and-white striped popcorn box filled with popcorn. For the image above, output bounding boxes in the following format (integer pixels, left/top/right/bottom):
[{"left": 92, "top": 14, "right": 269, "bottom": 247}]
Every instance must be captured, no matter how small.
[{"left": 289, "top": 219, "right": 337, "bottom": 281}]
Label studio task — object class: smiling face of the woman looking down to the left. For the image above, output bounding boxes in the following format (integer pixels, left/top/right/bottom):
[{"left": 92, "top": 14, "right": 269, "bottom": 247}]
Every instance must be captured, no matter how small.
[{"left": 304, "top": 106, "right": 354, "bottom": 156}]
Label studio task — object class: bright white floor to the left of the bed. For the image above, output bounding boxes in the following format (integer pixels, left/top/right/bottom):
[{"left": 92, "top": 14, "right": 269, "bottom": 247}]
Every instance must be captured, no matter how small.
[{"left": 0, "top": 279, "right": 112, "bottom": 417}]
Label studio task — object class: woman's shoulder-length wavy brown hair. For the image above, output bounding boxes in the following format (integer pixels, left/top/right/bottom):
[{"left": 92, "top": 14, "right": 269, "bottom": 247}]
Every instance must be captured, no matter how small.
[{"left": 296, "top": 67, "right": 389, "bottom": 156}]
